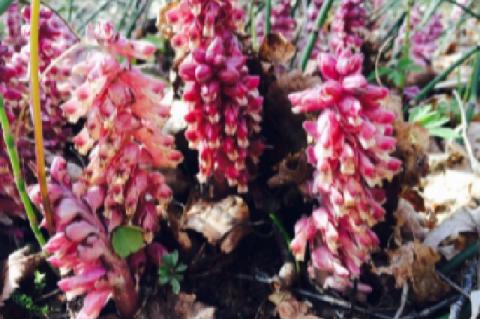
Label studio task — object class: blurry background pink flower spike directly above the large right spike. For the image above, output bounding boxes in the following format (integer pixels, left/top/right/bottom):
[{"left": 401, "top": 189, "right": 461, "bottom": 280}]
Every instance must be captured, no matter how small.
[{"left": 330, "top": 0, "right": 366, "bottom": 50}]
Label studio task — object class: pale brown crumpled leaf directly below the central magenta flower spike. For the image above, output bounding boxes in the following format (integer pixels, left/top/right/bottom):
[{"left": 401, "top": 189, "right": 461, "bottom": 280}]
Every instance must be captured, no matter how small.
[{"left": 182, "top": 196, "right": 250, "bottom": 254}]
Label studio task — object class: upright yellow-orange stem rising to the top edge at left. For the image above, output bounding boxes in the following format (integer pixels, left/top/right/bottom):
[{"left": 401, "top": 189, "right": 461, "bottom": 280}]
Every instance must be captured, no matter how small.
[{"left": 30, "top": 0, "right": 53, "bottom": 233}]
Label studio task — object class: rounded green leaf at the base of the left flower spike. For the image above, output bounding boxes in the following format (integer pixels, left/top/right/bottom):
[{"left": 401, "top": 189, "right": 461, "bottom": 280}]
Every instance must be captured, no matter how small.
[{"left": 112, "top": 226, "right": 145, "bottom": 258}]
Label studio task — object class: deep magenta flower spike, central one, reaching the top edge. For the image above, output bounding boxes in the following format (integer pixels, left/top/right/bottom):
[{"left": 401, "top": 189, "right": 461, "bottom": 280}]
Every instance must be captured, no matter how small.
[{"left": 167, "top": 0, "right": 263, "bottom": 192}]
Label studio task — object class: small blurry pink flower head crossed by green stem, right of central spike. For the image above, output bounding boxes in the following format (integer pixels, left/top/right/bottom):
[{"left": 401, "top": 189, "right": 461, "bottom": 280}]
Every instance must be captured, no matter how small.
[{"left": 256, "top": 0, "right": 296, "bottom": 43}]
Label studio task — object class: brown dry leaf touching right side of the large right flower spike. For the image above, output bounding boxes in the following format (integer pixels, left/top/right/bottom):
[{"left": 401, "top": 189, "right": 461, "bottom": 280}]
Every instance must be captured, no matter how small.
[{"left": 395, "top": 122, "right": 430, "bottom": 185}]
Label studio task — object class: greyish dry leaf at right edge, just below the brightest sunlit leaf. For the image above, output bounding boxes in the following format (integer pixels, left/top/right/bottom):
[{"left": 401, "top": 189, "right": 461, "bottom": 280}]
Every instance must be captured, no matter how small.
[{"left": 424, "top": 207, "right": 480, "bottom": 259}]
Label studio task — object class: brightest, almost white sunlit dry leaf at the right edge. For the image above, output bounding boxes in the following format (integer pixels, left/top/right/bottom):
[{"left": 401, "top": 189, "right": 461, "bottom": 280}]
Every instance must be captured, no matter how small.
[{"left": 422, "top": 169, "right": 480, "bottom": 213}]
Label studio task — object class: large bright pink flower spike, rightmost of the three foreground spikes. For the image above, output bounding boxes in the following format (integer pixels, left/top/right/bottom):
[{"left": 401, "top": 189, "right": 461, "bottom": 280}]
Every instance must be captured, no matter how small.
[{"left": 290, "top": 50, "right": 401, "bottom": 290}]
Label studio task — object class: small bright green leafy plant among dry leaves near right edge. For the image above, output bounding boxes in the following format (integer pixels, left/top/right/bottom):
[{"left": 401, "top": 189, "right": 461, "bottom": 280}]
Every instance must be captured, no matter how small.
[{"left": 408, "top": 104, "right": 460, "bottom": 139}]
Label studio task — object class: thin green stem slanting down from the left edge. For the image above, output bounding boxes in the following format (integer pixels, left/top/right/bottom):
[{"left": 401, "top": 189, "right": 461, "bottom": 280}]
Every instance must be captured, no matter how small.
[{"left": 0, "top": 96, "right": 45, "bottom": 246}]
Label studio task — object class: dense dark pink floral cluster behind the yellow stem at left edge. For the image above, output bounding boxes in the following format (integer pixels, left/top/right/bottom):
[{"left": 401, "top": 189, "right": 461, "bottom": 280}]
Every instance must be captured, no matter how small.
[{"left": 0, "top": 2, "right": 76, "bottom": 225}]
